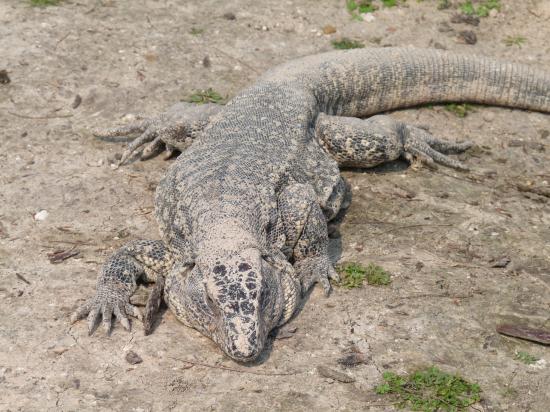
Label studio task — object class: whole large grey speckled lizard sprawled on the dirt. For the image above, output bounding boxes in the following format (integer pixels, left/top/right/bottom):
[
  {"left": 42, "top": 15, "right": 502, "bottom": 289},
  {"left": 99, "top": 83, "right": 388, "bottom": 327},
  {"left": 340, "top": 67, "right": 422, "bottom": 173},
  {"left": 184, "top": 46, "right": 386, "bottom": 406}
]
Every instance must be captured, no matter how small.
[{"left": 72, "top": 48, "right": 550, "bottom": 362}]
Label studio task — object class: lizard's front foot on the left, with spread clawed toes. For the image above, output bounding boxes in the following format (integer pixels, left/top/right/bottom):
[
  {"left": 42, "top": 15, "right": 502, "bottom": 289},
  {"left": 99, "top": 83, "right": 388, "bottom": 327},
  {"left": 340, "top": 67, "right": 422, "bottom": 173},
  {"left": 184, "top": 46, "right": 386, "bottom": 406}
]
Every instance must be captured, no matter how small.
[{"left": 71, "top": 289, "right": 143, "bottom": 335}]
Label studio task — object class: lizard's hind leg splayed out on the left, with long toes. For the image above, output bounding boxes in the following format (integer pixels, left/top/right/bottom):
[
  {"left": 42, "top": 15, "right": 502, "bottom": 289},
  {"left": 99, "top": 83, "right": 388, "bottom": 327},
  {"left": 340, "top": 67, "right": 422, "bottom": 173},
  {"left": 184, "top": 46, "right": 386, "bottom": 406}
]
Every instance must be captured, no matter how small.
[{"left": 92, "top": 102, "right": 221, "bottom": 165}]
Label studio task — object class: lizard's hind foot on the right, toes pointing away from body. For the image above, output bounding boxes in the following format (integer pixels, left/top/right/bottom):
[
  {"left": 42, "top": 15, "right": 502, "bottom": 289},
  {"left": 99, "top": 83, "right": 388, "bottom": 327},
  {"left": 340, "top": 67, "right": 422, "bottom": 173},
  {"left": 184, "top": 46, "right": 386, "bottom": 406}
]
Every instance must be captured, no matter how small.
[{"left": 403, "top": 126, "right": 473, "bottom": 170}]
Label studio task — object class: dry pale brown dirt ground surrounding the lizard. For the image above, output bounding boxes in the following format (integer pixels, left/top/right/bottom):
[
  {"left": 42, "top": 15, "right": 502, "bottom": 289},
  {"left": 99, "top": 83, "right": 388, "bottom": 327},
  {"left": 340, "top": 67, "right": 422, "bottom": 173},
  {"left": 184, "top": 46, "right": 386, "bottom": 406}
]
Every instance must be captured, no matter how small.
[{"left": 0, "top": 0, "right": 550, "bottom": 411}]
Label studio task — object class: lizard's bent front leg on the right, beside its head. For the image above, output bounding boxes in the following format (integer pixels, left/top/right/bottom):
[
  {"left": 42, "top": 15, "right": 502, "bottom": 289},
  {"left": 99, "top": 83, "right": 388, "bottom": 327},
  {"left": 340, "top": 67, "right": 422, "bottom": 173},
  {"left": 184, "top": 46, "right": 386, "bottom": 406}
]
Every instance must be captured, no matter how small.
[{"left": 278, "top": 184, "right": 338, "bottom": 295}]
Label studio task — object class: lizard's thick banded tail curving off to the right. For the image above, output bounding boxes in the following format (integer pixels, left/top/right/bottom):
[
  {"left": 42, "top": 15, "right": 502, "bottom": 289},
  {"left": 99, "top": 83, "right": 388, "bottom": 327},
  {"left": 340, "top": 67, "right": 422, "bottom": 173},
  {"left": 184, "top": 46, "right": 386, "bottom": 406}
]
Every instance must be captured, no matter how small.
[{"left": 264, "top": 48, "right": 550, "bottom": 117}]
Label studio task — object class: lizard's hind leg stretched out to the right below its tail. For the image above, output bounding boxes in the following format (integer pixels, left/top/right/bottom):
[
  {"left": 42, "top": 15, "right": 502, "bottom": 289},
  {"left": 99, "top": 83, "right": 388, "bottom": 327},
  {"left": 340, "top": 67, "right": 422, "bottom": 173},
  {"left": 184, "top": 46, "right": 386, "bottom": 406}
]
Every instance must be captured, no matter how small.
[{"left": 315, "top": 113, "right": 472, "bottom": 170}]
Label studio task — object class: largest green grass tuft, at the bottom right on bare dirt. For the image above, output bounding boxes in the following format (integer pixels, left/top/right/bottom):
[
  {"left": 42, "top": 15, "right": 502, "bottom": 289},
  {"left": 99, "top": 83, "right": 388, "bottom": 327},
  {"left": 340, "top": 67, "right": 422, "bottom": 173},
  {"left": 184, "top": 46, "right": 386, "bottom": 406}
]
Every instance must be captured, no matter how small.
[{"left": 375, "top": 366, "right": 481, "bottom": 412}]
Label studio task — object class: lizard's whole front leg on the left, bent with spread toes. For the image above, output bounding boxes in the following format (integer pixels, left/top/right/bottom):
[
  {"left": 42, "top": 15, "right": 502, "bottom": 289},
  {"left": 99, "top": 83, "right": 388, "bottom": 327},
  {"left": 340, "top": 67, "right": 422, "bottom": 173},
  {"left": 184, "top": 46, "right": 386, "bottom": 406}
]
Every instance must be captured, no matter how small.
[{"left": 71, "top": 240, "right": 173, "bottom": 334}]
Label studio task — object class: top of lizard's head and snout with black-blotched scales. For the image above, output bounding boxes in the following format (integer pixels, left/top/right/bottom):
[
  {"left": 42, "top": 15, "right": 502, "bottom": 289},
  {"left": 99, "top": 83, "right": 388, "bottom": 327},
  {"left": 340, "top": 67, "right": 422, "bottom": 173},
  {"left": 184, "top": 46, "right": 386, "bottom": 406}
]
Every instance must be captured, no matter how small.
[{"left": 201, "top": 248, "right": 283, "bottom": 362}]
